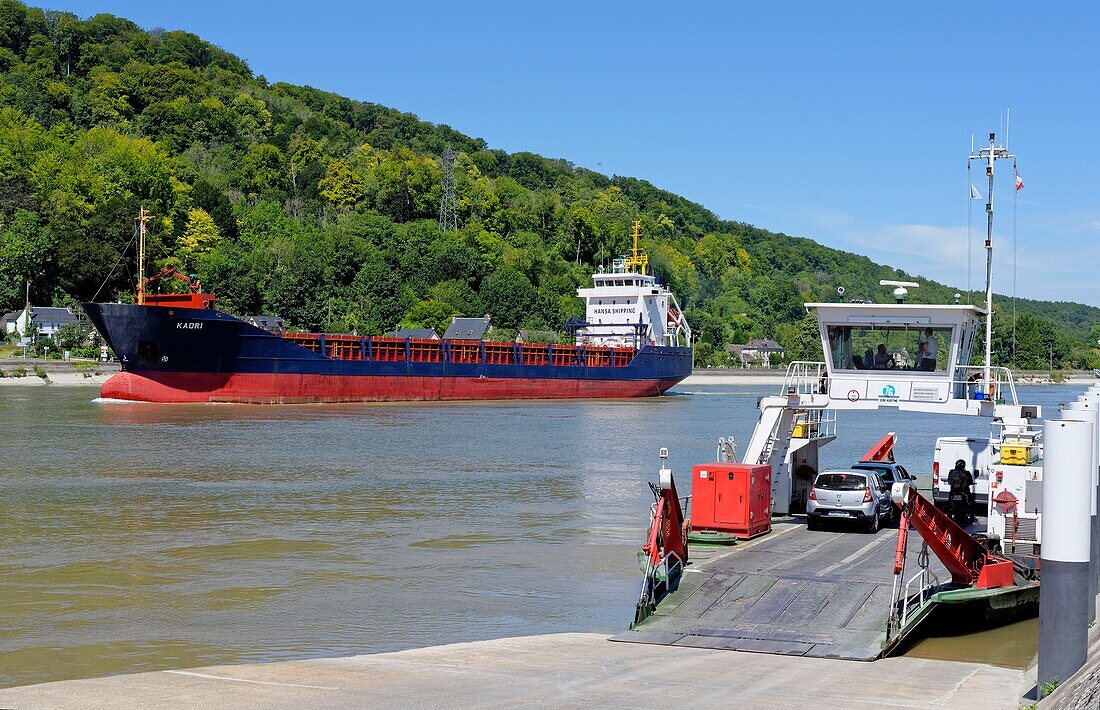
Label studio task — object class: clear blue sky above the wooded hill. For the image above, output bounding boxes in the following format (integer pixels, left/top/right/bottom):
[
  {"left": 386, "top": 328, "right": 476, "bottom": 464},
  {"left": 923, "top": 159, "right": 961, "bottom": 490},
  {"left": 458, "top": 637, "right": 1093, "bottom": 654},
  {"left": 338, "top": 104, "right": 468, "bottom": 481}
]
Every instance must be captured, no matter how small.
[{"left": 55, "top": 0, "right": 1100, "bottom": 306}]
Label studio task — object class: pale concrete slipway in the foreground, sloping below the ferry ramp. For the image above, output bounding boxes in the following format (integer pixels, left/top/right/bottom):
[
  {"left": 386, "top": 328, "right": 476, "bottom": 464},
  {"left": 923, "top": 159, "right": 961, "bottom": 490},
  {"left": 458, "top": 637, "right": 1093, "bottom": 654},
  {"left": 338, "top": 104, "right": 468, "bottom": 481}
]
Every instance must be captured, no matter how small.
[{"left": 0, "top": 633, "right": 1034, "bottom": 710}]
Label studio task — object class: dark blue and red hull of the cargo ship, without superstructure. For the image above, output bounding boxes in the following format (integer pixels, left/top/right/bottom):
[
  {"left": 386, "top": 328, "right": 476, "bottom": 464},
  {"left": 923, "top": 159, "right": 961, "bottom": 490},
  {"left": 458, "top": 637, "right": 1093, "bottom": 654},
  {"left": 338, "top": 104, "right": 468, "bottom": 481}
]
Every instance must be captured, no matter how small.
[{"left": 85, "top": 303, "right": 692, "bottom": 403}]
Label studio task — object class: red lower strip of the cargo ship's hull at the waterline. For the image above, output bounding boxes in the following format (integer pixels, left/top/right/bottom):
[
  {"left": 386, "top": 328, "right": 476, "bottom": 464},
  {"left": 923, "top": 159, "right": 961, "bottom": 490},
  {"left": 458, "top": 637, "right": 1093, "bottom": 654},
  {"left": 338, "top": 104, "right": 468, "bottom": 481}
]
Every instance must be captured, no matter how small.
[{"left": 100, "top": 372, "right": 680, "bottom": 404}]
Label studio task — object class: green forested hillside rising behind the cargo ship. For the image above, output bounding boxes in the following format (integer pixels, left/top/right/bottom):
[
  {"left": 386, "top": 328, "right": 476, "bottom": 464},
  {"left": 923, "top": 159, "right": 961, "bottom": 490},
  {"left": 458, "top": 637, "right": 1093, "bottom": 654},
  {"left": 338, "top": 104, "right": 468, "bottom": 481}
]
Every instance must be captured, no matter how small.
[{"left": 0, "top": 0, "right": 1100, "bottom": 368}]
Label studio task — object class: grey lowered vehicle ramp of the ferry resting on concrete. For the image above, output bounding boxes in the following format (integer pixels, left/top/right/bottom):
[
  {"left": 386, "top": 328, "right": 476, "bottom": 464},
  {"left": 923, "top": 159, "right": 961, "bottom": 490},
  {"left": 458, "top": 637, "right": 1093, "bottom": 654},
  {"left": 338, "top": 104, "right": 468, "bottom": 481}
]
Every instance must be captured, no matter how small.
[{"left": 613, "top": 522, "right": 950, "bottom": 660}]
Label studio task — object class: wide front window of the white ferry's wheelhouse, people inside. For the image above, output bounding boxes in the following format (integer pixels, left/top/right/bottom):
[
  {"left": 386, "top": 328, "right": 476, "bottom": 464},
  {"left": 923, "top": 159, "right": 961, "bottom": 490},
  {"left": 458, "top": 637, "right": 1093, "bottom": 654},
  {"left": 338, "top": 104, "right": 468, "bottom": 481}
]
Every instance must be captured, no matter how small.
[{"left": 827, "top": 325, "right": 953, "bottom": 372}]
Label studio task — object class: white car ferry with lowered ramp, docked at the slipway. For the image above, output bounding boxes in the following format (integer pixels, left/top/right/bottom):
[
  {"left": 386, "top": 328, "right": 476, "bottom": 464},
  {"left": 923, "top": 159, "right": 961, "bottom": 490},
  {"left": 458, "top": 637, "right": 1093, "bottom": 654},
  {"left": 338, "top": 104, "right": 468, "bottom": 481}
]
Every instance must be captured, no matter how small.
[{"left": 613, "top": 133, "right": 1056, "bottom": 660}]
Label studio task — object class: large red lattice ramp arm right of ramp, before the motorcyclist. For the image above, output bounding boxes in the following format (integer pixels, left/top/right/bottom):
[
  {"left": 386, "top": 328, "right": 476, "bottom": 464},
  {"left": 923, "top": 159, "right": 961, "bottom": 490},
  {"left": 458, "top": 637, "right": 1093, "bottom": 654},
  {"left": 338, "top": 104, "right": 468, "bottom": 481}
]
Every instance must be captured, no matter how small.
[{"left": 891, "top": 483, "right": 1015, "bottom": 589}]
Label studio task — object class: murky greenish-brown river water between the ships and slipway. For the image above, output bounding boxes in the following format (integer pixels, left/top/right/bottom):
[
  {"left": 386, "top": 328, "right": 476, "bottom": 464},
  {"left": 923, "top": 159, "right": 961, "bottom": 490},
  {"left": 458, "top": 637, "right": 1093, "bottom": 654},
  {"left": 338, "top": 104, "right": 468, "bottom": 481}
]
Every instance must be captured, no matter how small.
[{"left": 0, "top": 386, "right": 1080, "bottom": 686}]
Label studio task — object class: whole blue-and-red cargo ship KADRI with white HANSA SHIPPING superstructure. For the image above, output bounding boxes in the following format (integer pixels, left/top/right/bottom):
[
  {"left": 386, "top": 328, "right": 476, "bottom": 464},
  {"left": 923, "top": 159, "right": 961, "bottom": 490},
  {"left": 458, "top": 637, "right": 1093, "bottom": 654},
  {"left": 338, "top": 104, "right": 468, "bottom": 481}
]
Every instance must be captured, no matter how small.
[{"left": 84, "top": 219, "right": 692, "bottom": 404}]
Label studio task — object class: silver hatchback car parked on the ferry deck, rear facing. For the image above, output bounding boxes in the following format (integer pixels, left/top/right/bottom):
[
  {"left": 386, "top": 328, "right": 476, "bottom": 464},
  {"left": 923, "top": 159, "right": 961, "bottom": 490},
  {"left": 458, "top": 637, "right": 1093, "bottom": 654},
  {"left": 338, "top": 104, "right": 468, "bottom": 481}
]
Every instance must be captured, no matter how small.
[{"left": 806, "top": 469, "right": 893, "bottom": 533}]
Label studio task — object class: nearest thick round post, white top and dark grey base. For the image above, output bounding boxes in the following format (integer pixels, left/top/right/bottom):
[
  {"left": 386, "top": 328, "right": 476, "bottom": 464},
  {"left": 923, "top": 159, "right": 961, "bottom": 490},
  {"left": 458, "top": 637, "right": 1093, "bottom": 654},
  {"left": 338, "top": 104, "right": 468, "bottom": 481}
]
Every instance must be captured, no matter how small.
[{"left": 1037, "top": 419, "right": 1093, "bottom": 688}]
